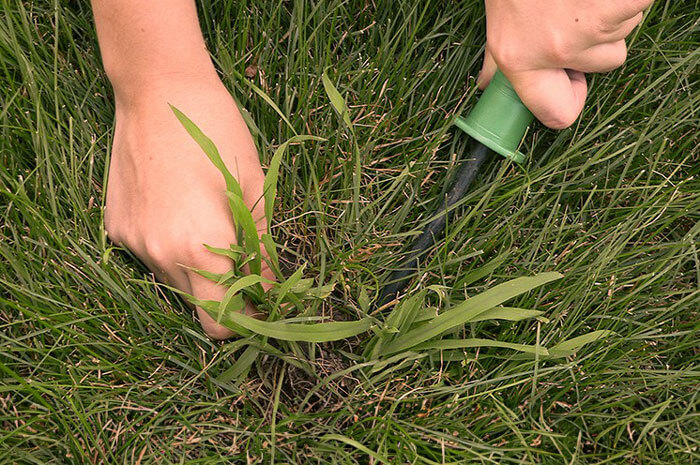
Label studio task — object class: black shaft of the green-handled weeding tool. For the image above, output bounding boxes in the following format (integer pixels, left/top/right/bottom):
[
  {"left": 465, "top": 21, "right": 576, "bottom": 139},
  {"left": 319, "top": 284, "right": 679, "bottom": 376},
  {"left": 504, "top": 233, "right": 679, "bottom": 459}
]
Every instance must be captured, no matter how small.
[{"left": 378, "top": 140, "right": 491, "bottom": 306}]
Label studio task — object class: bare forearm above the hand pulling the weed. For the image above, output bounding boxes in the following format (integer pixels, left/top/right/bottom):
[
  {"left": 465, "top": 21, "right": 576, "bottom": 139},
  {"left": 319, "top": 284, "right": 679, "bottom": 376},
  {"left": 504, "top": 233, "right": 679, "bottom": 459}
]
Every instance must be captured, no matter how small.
[{"left": 92, "top": 0, "right": 216, "bottom": 97}]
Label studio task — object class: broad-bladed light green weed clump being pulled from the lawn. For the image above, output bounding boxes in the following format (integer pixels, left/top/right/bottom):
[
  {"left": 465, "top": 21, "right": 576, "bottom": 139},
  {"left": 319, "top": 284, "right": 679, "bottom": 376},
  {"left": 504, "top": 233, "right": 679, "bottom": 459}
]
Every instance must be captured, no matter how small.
[{"left": 171, "top": 96, "right": 612, "bottom": 382}]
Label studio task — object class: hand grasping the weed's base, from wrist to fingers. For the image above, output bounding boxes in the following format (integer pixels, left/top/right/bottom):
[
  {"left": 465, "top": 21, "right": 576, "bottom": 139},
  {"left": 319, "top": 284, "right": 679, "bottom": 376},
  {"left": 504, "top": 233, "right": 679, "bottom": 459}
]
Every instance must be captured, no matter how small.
[{"left": 105, "top": 75, "right": 274, "bottom": 339}]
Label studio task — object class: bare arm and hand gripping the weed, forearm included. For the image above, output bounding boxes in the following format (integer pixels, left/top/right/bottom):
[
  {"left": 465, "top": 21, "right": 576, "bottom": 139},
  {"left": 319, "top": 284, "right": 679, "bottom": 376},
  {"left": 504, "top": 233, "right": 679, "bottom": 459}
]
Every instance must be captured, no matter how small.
[{"left": 92, "top": 0, "right": 274, "bottom": 339}]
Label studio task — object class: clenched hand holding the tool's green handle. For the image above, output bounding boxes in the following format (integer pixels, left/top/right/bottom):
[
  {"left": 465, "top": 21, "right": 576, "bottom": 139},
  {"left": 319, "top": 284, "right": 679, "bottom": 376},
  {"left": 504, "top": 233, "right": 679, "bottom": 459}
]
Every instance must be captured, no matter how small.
[{"left": 479, "top": 0, "right": 653, "bottom": 129}]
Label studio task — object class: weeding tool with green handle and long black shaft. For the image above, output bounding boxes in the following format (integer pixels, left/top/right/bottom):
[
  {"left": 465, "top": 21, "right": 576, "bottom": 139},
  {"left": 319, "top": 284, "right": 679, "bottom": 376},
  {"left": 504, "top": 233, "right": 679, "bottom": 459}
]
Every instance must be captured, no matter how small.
[{"left": 378, "top": 71, "right": 535, "bottom": 306}]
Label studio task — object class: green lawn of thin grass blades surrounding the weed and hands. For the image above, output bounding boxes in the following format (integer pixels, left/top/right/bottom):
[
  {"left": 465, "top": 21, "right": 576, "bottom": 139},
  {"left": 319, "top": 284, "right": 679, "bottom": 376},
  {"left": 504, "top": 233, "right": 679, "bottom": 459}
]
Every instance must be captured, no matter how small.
[{"left": 0, "top": 0, "right": 700, "bottom": 465}]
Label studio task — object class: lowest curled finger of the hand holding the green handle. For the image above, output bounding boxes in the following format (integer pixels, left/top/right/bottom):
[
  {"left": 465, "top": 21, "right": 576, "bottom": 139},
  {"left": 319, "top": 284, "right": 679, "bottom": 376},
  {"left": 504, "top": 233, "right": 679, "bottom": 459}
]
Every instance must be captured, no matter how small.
[{"left": 506, "top": 69, "right": 587, "bottom": 129}]
